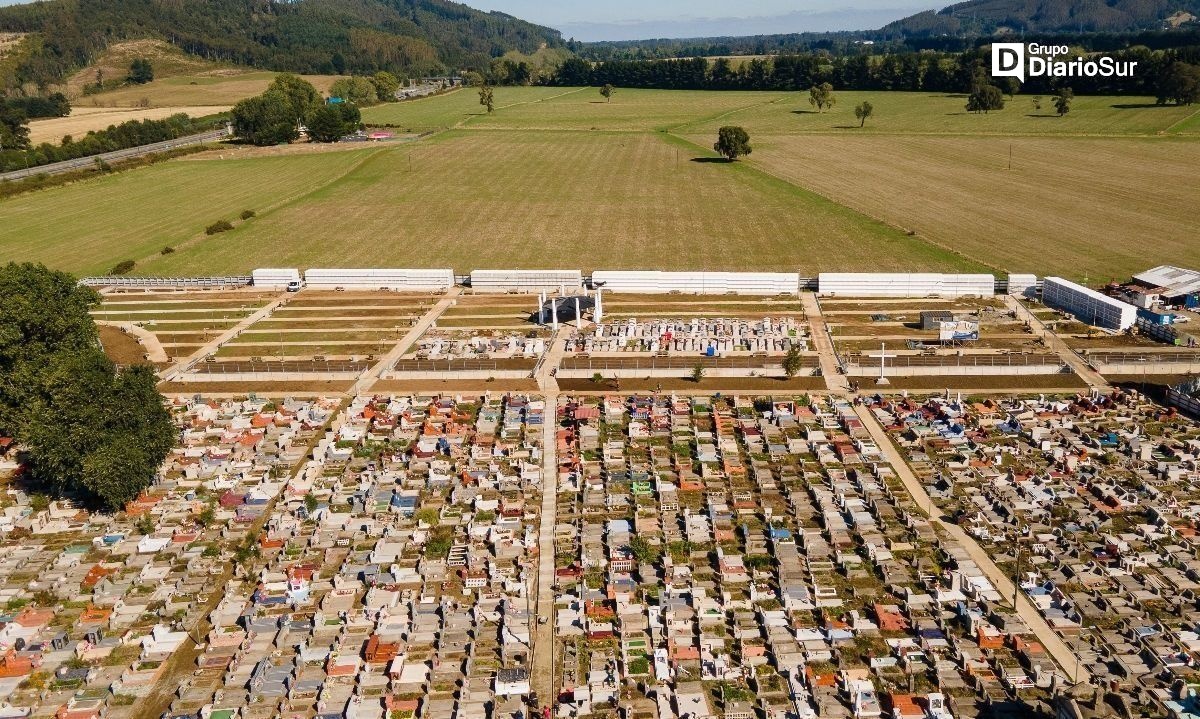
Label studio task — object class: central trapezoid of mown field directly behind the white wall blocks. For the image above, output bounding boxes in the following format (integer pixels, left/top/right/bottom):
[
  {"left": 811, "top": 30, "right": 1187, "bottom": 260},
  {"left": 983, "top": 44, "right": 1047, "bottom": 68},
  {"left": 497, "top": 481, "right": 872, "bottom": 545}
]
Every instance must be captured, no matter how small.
[{"left": 144, "top": 131, "right": 964, "bottom": 274}]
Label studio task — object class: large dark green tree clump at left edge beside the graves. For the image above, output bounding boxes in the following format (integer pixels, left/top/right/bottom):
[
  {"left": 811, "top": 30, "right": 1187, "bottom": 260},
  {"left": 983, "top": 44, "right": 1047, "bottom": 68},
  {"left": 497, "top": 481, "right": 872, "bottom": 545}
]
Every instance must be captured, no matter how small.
[{"left": 0, "top": 263, "right": 175, "bottom": 510}]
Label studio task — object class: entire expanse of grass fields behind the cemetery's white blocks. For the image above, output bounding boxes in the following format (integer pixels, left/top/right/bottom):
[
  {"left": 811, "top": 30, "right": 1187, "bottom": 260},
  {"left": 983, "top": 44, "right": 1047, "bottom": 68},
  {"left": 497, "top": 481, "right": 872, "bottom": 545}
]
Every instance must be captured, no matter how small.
[{"left": 0, "top": 83, "right": 1200, "bottom": 280}]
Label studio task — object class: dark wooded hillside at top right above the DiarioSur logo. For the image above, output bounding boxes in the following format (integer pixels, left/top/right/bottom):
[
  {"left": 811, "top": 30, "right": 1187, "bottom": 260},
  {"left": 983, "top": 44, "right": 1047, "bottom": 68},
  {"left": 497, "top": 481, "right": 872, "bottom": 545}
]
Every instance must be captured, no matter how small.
[{"left": 881, "top": 0, "right": 1200, "bottom": 36}]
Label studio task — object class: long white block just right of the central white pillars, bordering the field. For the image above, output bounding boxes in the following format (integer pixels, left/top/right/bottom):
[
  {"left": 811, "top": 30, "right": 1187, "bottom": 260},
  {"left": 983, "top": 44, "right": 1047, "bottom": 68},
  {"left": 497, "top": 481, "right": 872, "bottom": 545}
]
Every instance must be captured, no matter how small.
[{"left": 592, "top": 270, "right": 800, "bottom": 296}]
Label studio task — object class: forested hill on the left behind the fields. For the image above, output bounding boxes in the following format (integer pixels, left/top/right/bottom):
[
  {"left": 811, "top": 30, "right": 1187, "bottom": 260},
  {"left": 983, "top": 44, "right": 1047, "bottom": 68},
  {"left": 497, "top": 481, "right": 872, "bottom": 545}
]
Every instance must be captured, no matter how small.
[{"left": 0, "top": 0, "right": 563, "bottom": 86}]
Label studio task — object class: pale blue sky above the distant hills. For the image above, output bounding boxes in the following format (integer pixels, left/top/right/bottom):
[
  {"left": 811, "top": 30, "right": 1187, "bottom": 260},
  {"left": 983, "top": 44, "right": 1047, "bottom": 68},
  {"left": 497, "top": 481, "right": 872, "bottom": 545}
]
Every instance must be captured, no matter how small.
[{"left": 462, "top": 0, "right": 926, "bottom": 41}]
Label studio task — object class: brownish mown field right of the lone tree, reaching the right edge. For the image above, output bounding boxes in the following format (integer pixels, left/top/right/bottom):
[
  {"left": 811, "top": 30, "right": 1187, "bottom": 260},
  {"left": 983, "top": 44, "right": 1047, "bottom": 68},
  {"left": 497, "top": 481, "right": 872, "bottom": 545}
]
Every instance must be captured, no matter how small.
[{"left": 729, "top": 136, "right": 1200, "bottom": 282}]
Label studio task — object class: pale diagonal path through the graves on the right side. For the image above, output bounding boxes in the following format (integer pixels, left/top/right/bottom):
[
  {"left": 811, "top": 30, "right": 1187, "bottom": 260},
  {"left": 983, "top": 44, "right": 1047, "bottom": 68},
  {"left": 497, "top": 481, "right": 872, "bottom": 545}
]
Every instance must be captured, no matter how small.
[{"left": 854, "top": 406, "right": 1091, "bottom": 682}]
